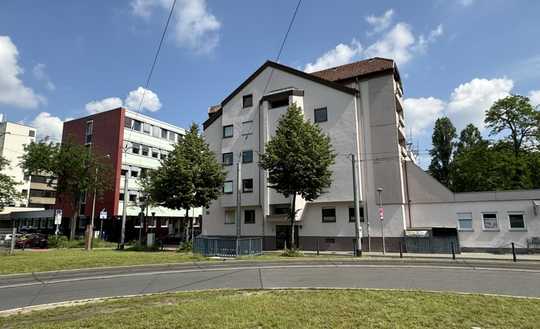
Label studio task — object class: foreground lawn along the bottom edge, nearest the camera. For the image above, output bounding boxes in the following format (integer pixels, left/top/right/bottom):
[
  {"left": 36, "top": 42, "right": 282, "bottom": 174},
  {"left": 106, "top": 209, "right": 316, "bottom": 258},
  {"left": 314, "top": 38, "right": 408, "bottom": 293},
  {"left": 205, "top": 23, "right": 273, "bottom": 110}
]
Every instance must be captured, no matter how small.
[{"left": 0, "top": 290, "right": 540, "bottom": 329}]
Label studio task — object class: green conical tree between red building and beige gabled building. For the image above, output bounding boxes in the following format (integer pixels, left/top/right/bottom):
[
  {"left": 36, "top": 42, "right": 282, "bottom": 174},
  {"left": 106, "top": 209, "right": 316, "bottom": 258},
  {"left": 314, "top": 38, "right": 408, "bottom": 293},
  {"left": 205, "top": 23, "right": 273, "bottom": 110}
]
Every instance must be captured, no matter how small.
[{"left": 145, "top": 123, "right": 225, "bottom": 239}]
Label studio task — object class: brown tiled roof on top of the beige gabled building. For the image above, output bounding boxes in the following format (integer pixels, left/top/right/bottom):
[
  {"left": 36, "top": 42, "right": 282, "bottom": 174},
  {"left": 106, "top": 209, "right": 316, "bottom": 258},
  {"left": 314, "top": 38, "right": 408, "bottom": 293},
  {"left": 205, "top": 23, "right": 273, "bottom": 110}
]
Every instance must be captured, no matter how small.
[{"left": 311, "top": 57, "right": 397, "bottom": 81}]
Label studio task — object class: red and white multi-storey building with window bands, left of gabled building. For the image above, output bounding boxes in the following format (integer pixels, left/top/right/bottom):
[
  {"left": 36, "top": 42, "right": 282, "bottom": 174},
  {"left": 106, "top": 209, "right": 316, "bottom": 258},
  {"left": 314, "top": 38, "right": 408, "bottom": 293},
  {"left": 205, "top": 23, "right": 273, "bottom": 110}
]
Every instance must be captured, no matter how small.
[{"left": 57, "top": 108, "right": 200, "bottom": 239}]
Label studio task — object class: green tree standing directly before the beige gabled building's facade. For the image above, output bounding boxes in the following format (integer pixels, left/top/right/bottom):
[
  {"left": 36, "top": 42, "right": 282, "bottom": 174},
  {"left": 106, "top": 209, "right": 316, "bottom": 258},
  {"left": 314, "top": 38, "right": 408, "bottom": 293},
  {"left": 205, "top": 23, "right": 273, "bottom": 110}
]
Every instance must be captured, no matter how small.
[{"left": 259, "top": 104, "right": 336, "bottom": 247}]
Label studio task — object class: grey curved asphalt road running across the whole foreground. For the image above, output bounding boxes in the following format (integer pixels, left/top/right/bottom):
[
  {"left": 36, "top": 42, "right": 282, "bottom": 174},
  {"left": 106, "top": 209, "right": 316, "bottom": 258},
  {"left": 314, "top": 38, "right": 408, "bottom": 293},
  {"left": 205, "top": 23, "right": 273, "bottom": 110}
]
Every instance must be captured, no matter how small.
[{"left": 0, "top": 262, "right": 540, "bottom": 310}]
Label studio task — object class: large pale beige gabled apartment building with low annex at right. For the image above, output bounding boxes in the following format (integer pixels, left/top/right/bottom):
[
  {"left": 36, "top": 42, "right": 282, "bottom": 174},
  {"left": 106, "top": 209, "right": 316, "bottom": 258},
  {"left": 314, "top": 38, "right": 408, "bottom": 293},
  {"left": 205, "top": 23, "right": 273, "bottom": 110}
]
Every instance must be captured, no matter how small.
[{"left": 202, "top": 58, "right": 540, "bottom": 250}]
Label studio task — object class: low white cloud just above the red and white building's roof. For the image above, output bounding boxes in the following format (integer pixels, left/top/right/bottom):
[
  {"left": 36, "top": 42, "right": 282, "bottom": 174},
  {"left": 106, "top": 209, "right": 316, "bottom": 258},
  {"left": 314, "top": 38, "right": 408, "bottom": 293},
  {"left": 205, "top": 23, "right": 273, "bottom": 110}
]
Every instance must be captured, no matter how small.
[{"left": 85, "top": 87, "right": 161, "bottom": 114}]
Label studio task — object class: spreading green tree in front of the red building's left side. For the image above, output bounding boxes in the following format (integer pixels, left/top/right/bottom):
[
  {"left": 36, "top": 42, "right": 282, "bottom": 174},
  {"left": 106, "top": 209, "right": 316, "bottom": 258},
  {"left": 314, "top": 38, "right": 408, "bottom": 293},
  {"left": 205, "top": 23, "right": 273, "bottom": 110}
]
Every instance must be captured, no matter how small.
[{"left": 21, "top": 140, "right": 112, "bottom": 239}]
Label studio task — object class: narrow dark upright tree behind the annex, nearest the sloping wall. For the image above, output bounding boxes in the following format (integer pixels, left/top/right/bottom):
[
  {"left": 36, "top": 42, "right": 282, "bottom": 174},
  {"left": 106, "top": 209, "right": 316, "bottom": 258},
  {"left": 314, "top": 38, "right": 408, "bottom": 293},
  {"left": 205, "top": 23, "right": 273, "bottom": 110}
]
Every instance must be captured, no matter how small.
[{"left": 429, "top": 117, "right": 456, "bottom": 186}]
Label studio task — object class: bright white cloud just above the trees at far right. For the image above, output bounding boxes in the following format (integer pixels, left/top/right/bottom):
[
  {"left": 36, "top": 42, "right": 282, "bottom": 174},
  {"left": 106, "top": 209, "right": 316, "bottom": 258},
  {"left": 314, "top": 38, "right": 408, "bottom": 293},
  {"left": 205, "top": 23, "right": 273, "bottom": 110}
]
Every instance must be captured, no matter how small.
[{"left": 448, "top": 78, "right": 514, "bottom": 130}]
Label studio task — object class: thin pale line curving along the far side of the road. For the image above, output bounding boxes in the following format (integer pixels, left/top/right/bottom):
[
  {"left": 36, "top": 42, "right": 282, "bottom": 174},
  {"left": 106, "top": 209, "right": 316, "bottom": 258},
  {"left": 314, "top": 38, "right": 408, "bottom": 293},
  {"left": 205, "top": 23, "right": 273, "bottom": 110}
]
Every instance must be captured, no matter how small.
[{"left": 0, "top": 264, "right": 540, "bottom": 289}]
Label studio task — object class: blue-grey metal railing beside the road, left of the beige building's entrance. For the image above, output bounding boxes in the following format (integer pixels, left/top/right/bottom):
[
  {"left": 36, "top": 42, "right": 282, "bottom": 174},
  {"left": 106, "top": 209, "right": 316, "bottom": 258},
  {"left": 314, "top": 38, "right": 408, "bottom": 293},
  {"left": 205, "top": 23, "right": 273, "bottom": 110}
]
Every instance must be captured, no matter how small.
[{"left": 193, "top": 237, "right": 263, "bottom": 257}]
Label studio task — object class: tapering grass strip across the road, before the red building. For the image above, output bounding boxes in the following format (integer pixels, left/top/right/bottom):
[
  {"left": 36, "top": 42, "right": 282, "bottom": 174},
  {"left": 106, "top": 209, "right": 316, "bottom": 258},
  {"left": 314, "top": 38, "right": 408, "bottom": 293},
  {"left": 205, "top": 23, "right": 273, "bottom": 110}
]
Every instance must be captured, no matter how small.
[{"left": 0, "top": 249, "right": 205, "bottom": 274}]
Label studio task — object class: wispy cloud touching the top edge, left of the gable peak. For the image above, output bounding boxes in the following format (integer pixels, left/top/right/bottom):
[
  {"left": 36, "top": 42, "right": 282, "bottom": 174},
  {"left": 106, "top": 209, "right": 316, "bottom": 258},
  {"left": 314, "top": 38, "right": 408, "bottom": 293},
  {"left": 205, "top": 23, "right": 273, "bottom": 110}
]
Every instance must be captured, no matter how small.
[{"left": 131, "top": 0, "right": 221, "bottom": 53}]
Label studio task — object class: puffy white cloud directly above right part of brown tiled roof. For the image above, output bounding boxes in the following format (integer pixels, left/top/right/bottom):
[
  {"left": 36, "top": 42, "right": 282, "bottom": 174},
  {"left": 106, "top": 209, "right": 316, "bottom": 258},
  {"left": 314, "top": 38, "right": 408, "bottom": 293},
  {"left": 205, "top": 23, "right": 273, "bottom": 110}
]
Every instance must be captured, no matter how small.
[{"left": 365, "top": 23, "right": 415, "bottom": 64}]
